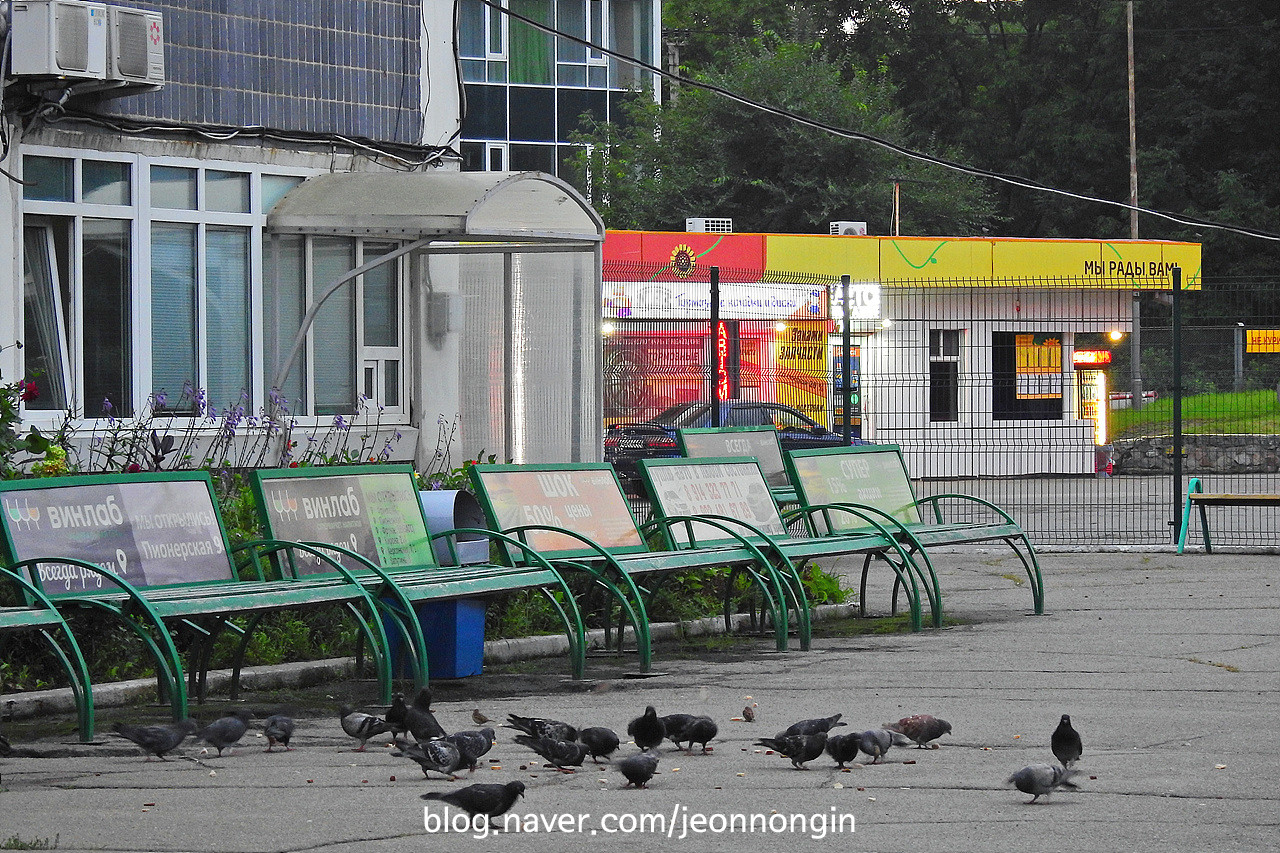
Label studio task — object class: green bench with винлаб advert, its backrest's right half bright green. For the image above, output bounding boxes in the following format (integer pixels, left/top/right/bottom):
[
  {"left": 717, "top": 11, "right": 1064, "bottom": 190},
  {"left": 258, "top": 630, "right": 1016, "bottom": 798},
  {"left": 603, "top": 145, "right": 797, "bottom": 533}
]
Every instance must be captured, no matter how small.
[{"left": 251, "top": 465, "right": 586, "bottom": 680}]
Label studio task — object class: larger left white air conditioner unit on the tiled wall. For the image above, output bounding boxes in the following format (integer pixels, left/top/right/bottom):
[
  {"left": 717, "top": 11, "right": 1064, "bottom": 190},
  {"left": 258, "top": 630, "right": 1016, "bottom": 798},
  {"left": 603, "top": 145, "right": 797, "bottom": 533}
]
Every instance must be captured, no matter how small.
[{"left": 9, "top": 0, "right": 106, "bottom": 79}]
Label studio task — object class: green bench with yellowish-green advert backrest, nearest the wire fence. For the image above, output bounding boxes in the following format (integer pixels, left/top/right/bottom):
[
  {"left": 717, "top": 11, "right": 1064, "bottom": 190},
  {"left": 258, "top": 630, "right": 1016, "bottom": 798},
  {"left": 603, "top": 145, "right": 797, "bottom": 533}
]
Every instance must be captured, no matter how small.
[{"left": 787, "top": 444, "right": 1044, "bottom": 613}]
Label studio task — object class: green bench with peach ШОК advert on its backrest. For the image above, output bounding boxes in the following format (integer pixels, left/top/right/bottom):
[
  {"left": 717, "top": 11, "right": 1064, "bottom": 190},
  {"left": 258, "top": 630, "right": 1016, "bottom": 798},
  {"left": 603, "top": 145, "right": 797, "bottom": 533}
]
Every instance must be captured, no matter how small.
[{"left": 470, "top": 462, "right": 809, "bottom": 671}]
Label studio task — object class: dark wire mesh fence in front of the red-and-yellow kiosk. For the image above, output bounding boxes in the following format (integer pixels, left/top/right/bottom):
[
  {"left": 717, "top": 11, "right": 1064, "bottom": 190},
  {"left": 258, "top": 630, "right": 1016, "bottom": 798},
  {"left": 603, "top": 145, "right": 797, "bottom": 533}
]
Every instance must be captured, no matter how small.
[{"left": 604, "top": 258, "right": 1280, "bottom": 546}]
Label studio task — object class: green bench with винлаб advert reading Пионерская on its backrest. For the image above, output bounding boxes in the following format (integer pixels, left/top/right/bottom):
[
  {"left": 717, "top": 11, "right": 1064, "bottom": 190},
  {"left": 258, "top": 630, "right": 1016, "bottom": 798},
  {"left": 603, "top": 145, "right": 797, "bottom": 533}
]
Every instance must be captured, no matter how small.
[{"left": 0, "top": 471, "right": 424, "bottom": 720}]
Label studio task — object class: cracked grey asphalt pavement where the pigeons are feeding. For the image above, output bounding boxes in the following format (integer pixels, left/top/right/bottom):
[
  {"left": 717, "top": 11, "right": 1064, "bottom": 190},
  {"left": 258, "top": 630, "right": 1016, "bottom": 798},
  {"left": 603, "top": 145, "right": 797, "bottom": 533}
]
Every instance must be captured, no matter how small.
[{"left": 0, "top": 549, "right": 1280, "bottom": 853}]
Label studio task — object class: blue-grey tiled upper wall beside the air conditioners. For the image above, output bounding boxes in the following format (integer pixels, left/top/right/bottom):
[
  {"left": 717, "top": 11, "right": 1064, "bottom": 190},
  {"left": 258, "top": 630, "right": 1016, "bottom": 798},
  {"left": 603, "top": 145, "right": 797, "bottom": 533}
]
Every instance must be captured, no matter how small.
[{"left": 97, "top": 0, "right": 424, "bottom": 143}]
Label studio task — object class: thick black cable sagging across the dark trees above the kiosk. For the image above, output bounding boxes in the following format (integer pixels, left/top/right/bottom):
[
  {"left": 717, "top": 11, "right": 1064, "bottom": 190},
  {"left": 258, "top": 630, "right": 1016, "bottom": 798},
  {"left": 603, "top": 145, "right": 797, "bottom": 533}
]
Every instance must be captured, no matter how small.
[{"left": 480, "top": 0, "right": 1280, "bottom": 241}]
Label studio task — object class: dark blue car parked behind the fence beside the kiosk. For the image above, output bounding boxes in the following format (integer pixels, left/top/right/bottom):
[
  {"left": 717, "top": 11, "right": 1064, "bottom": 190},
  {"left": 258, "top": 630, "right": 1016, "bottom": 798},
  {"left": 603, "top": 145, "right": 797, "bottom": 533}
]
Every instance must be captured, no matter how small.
[{"left": 604, "top": 401, "right": 868, "bottom": 484}]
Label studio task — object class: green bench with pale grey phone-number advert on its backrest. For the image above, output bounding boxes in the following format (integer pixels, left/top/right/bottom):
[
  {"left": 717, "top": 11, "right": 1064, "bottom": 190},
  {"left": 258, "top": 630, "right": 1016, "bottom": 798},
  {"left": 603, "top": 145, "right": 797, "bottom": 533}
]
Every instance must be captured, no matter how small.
[{"left": 639, "top": 456, "right": 941, "bottom": 630}]
